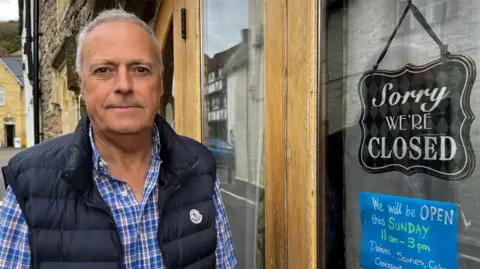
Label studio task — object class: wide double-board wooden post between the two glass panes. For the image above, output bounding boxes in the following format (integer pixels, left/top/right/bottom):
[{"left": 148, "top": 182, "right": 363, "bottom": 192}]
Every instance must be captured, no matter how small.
[{"left": 264, "top": 0, "right": 323, "bottom": 269}]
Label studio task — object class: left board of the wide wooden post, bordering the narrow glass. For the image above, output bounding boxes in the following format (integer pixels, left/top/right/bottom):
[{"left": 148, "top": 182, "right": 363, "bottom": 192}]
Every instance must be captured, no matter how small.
[{"left": 264, "top": 0, "right": 286, "bottom": 269}]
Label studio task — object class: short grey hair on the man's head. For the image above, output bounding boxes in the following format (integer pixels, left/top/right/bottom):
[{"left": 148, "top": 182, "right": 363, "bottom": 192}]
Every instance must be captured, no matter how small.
[{"left": 76, "top": 9, "right": 163, "bottom": 75}]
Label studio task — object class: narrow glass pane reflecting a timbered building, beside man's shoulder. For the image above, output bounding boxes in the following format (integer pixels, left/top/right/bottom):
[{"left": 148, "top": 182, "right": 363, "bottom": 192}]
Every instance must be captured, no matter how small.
[{"left": 202, "top": 0, "right": 265, "bottom": 269}]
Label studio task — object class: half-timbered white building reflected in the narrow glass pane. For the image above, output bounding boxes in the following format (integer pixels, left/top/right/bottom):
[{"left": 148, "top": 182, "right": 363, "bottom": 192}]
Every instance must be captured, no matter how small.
[{"left": 205, "top": 29, "right": 250, "bottom": 181}]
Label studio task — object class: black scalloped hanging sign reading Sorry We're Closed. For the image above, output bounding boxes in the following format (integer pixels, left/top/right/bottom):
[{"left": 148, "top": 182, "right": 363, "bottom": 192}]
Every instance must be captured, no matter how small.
[{"left": 359, "top": 54, "right": 476, "bottom": 180}]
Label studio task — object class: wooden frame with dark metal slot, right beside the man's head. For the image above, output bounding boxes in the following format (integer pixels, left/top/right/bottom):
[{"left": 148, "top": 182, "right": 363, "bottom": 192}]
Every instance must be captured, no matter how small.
[{"left": 154, "top": 0, "right": 201, "bottom": 141}]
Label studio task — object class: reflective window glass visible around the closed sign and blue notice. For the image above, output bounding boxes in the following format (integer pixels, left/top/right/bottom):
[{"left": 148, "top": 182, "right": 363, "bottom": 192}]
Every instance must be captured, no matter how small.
[{"left": 322, "top": 0, "right": 480, "bottom": 269}]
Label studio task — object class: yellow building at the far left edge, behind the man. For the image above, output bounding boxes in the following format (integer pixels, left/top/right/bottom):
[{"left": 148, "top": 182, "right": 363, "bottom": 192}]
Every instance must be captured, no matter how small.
[{"left": 0, "top": 56, "right": 26, "bottom": 147}]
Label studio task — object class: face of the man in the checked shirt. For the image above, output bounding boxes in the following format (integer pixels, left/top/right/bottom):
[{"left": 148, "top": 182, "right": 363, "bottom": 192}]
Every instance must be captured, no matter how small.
[{"left": 77, "top": 21, "right": 162, "bottom": 135}]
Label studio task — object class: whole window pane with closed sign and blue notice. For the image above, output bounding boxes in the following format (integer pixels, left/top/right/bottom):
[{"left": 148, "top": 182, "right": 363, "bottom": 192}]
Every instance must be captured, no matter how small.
[{"left": 320, "top": 0, "right": 480, "bottom": 269}]
